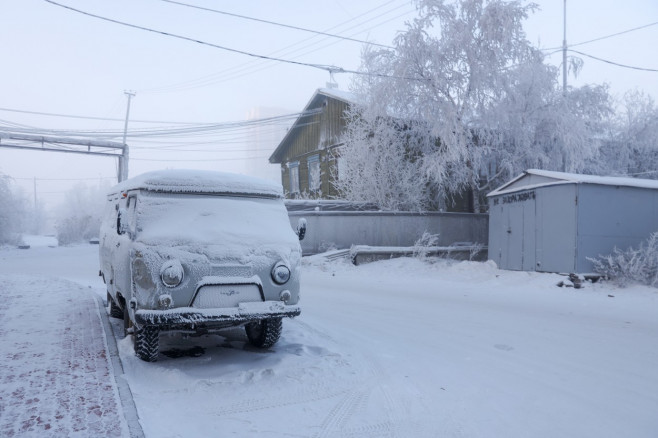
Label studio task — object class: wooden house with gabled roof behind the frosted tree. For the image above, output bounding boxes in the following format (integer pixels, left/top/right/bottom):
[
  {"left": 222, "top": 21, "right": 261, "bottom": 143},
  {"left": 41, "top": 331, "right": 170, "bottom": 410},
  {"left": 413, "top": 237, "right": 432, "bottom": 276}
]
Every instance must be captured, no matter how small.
[{"left": 269, "top": 88, "right": 355, "bottom": 199}]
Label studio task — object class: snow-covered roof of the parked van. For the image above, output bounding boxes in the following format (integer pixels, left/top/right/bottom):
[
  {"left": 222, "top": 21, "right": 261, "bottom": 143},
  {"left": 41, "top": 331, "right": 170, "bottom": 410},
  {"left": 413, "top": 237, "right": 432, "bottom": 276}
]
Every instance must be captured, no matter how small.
[{"left": 109, "top": 169, "right": 283, "bottom": 198}]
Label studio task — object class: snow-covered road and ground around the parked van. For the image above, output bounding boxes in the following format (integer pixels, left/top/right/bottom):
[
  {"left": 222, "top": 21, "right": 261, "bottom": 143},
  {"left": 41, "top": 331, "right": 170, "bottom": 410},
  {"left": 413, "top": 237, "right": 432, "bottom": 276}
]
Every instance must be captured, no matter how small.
[{"left": 0, "top": 242, "right": 658, "bottom": 438}]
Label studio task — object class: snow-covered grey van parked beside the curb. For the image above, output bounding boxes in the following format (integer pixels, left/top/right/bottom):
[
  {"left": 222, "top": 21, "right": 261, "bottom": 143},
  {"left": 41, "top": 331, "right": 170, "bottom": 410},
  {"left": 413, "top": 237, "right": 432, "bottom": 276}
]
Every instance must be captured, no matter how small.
[{"left": 100, "top": 170, "right": 306, "bottom": 362}]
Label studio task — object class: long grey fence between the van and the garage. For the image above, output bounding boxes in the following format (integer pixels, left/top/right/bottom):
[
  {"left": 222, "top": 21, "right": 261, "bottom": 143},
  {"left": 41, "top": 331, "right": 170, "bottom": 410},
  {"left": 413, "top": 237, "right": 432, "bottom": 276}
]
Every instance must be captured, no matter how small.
[{"left": 288, "top": 211, "right": 489, "bottom": 255}]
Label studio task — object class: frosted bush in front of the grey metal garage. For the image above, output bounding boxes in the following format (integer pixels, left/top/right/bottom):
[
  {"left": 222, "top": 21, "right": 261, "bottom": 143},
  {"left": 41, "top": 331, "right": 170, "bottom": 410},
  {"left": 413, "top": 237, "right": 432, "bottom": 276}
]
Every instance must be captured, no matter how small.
[{"left": 589, "top": 232, "right": 658, "bottom": 287}]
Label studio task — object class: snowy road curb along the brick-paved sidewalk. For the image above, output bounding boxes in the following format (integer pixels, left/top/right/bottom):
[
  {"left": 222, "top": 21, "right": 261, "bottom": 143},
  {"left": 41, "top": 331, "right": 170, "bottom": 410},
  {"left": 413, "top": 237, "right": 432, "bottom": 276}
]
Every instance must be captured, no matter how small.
[{"left": 96, "top": 296, "right": 145, "bottom": 438}]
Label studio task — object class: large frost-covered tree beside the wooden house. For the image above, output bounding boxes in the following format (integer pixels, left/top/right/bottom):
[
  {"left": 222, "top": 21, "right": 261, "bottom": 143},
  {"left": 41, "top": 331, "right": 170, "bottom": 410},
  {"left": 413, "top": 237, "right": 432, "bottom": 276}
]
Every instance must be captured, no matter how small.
[{"left": 336, "top": 0, "right": 609, "bottom": 210}]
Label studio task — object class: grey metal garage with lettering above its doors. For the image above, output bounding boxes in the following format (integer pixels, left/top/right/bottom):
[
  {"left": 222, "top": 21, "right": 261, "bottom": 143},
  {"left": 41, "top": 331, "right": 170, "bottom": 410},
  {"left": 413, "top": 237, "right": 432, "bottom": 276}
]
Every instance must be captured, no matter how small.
[{"left": 487, "top": 169, "right": 658, "bottom": 274}]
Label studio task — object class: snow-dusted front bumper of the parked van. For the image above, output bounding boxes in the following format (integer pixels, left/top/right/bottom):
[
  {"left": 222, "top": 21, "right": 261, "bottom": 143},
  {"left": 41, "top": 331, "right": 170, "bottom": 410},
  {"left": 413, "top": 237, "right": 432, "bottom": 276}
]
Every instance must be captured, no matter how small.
[{"left": 135, "top": 301, "right": 301, "bottom": 330}]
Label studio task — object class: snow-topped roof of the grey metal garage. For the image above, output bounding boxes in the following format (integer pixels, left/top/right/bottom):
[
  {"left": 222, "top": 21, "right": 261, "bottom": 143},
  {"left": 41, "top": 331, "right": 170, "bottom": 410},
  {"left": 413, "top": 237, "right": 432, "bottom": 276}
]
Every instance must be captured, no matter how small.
[{"left": 487, "top": 169, "right": 658, "bottom": 197}]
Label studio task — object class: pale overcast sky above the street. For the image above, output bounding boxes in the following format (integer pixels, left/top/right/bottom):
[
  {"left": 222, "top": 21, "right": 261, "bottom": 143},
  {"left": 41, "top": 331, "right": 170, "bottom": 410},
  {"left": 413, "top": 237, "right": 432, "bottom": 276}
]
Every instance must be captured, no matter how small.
[{"left": 0, "top": 0, "right": 658, "bottom": 210}]
